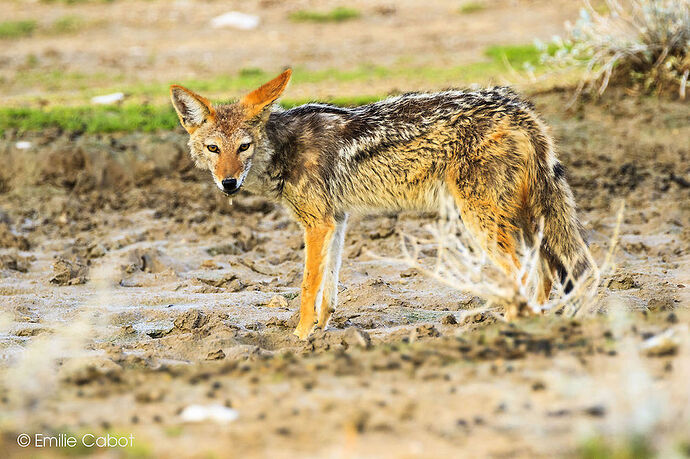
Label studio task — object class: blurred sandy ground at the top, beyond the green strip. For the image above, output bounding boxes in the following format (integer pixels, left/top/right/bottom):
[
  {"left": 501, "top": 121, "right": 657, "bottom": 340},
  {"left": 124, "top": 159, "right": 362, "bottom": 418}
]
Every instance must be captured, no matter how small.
[{"left": 0, "top": 0, "right": 580, "bottom": 103}]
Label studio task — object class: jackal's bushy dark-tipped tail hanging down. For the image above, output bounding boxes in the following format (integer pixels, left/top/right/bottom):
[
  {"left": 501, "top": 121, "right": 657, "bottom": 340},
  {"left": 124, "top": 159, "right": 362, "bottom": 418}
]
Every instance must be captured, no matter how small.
[{"left": 530, "top": 130, "right": 593, "bottom": 293}]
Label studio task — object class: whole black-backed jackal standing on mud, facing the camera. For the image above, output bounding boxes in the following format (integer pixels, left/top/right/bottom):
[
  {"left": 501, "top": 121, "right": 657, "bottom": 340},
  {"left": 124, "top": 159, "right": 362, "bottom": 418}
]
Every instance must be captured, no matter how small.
[{"left": 171, "top": 70, "right": 589, "bottom": 339}]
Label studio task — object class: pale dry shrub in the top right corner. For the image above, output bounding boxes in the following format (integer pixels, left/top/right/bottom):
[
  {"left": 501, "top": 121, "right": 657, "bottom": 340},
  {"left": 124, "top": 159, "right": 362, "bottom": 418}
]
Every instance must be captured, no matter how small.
[{"left": 545, "top": 0, "right": 690, "bottom": 101}]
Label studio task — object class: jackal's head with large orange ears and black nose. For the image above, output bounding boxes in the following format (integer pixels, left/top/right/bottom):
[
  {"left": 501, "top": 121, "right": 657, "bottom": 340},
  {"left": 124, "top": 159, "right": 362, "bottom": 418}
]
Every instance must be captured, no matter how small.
[{"left": 170, "top": 69, "right": 292, "bottom": 195}]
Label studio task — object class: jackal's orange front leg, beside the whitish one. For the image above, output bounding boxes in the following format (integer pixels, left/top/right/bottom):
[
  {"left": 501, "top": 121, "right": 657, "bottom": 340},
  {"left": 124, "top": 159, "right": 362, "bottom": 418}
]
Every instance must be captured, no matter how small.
[{"left": 294, "top": 221, "right": 335, "bottom": 339}]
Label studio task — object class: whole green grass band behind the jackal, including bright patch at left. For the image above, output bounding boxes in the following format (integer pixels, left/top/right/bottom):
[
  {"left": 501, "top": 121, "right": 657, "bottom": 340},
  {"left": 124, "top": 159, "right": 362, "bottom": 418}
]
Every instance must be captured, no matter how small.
[{"left": 0, "top": 45, "right": 556, "bottom": 133}]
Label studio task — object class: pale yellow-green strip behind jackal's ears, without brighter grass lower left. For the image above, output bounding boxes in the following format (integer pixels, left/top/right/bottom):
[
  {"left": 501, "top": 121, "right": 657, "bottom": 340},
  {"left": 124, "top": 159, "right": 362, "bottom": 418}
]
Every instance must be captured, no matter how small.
[{"left": 0, "top": 40, "right": 542, "bottom": 105}]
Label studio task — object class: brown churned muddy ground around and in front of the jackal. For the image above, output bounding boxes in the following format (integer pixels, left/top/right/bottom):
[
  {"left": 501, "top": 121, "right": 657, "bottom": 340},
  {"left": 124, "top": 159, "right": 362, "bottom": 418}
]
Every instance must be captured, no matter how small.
[{"left": 0, "top": 91, "right": 690, "bottom": 457}]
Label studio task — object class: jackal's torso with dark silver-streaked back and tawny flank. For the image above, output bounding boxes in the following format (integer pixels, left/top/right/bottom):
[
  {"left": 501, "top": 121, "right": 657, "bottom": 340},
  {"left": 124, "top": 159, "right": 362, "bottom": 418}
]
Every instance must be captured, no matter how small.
[{"left": 269, "top": 87, "right": 549, "bottom": 216}]
